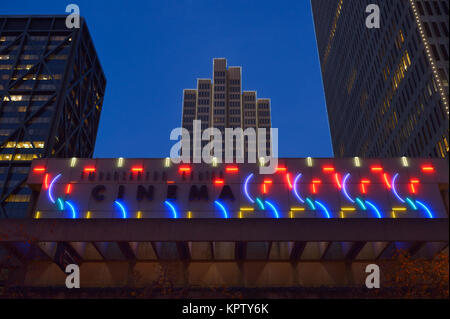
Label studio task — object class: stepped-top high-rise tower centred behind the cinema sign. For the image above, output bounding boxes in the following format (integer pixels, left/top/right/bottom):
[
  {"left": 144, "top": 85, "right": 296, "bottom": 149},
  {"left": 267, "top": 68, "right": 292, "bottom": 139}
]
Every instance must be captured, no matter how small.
[{"left": 182, "top": 58, "right": 272, "bottom": 159}]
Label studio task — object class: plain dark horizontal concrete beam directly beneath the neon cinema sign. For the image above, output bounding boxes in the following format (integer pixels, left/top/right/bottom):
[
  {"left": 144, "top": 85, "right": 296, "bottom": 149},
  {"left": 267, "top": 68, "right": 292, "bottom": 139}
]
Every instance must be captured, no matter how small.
[{"left": 0, "top": 218, "right": 449, "bottom": 242}]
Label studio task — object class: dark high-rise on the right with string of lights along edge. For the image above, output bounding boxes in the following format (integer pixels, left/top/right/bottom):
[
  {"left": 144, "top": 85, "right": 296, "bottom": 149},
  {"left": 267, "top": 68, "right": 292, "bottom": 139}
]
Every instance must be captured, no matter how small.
[{"left": 311, "top": 0, "right": 449, "bottom": 158}]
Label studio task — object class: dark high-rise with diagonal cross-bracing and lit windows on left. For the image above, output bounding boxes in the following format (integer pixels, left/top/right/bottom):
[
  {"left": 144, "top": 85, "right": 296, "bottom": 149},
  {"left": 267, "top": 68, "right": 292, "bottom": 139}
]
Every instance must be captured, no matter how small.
[{"left": 0, "top": 16, "right": 106, "bottom": 218}]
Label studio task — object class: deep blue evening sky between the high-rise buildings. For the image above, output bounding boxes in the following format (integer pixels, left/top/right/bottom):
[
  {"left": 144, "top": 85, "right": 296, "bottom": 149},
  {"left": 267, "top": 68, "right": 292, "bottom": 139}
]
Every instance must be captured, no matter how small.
[{"left": 0, "top": 0, "right": 333, "bottom": 157}]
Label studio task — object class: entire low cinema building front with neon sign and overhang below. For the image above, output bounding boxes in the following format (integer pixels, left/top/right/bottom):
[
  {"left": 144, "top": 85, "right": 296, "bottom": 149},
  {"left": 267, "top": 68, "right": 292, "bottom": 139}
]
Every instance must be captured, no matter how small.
[{"left": 0, "top": 158, "right": 449, "bottom": 296}]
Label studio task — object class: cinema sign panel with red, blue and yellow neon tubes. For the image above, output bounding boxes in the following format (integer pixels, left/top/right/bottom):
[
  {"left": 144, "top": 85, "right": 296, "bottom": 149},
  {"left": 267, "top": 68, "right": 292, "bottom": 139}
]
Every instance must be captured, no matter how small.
[{"left": 29, "top": 159, "right": 446, "bottom": 219}]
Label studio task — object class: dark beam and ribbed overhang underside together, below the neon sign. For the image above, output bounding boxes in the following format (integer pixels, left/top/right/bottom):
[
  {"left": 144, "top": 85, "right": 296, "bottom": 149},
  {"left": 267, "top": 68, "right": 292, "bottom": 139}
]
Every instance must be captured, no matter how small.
[{"left": 0, "top": 218, "right": 449, "bottom": 266}]
